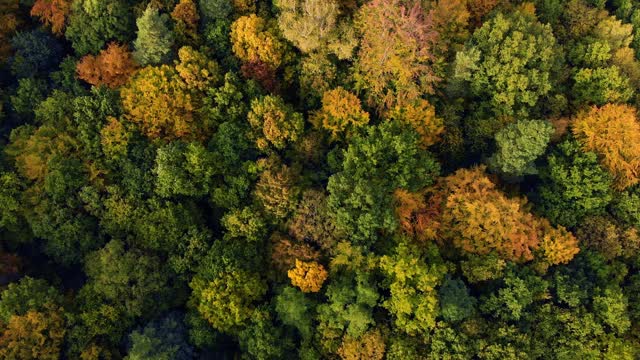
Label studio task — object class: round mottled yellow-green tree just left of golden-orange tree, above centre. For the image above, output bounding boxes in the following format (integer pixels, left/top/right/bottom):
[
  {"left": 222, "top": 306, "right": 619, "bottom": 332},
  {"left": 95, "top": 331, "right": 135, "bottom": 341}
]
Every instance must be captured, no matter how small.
[{"left": 247, "top": 95, "right": 304, "bottom": 150}]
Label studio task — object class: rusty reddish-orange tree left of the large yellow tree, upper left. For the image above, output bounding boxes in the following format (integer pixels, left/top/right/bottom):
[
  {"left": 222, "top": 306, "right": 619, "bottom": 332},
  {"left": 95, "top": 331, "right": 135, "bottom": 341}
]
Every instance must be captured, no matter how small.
[{"left": 77, "top": 42, "right": 137, "bottom": 89}]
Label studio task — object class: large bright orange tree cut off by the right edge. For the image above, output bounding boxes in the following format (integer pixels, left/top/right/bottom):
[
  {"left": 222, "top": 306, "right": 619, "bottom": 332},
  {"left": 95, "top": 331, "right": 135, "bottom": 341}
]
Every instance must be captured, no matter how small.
[{"left": 573, "top": 104, "right": 640, "bottom": 190}]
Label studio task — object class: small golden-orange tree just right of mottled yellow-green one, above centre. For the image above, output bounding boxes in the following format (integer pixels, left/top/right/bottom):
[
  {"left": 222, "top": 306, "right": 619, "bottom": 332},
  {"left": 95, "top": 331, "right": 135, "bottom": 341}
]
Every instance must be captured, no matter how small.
[{"left": 310, "top": 87, "right": 369, "bottom": 140}]
